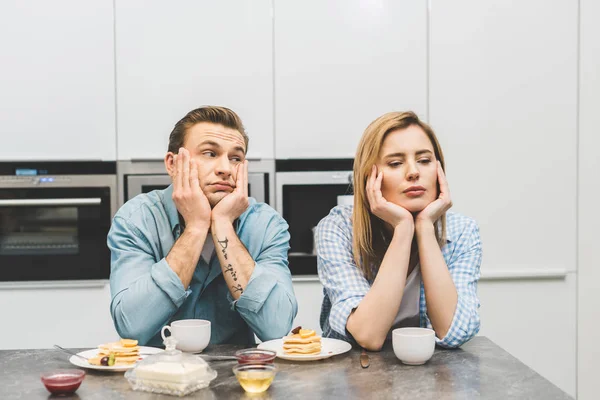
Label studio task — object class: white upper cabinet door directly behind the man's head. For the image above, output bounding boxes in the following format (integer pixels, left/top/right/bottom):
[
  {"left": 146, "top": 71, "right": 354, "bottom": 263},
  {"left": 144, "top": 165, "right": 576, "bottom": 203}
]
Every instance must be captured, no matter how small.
[{"left": 116, "top": 0, "right": 273, "bottom": 160}]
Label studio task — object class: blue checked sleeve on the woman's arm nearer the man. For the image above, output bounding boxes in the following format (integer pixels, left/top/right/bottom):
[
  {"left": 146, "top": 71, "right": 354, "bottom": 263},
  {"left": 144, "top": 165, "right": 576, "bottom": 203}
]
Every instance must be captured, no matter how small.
[{"left": 316, "top": 211, "right": 371, "bottom": 340}]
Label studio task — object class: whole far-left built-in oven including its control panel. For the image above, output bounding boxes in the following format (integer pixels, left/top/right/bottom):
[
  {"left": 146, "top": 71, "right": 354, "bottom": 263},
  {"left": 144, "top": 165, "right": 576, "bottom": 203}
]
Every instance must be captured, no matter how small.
[{"left": 0, "top": 161, "right": 117, "bottom": 282}]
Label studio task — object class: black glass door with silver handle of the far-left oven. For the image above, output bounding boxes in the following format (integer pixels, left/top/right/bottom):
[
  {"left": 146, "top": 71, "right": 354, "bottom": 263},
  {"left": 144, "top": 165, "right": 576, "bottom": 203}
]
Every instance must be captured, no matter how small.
[{"left": 0, "top": 187, "right": 111, "bottom": 281}]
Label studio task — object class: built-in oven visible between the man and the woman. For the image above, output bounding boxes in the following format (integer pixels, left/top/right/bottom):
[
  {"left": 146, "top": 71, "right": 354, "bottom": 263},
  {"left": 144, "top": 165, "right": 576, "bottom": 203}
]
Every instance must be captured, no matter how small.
[{"left": 275, "top": 159, "right": 353, "bottom": 277}]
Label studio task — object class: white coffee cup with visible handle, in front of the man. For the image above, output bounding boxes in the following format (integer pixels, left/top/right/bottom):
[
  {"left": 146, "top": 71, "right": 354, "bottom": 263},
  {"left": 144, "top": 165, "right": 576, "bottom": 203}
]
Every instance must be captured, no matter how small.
[{"left": 160, "top": 319, "right": 210, "bottom": 353}]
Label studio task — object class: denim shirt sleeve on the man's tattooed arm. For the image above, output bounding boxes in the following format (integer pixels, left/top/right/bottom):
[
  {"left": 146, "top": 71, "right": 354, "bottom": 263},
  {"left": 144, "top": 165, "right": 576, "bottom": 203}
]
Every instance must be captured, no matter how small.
[{"left": 227, "top": 213, "right": 298, "bottom": 341}]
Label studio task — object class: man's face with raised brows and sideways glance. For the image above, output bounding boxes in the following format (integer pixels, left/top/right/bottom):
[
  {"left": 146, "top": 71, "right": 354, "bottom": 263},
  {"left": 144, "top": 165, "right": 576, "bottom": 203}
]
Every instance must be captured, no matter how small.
[{"left": 167, "top": 122, "right": 246, "bottom": 207}]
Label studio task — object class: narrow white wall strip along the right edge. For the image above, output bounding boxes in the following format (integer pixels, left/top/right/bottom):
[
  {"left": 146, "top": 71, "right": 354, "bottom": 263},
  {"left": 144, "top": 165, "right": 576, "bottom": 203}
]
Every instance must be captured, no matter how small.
[{"left": 577, "top": 0, "right": 600, "bottom": 400}]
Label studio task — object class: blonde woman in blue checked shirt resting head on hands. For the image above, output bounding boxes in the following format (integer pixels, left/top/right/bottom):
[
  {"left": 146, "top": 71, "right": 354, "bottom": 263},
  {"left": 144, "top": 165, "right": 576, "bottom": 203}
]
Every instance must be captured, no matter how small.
[{"left": 316, "top": 112, "right": 481, "bottom": 350}]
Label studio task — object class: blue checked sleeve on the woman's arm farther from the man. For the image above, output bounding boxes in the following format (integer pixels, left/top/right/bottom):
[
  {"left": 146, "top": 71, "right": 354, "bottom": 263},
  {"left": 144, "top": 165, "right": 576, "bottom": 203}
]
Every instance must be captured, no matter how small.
[{"left": 426, "top": 221, "right": 482, "bottom": 348}]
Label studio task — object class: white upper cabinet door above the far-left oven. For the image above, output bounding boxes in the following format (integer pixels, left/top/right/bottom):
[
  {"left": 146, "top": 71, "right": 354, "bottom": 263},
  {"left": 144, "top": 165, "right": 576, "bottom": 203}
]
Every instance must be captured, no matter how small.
[{"left": 0, "top": 0, "right": 116, "bottom": 161}]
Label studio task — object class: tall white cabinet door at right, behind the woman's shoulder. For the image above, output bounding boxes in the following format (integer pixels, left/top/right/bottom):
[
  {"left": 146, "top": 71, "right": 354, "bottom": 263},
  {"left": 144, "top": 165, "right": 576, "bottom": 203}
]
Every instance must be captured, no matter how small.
[{"left": 429, "top": 0, "right": 578, "bottom": 278}]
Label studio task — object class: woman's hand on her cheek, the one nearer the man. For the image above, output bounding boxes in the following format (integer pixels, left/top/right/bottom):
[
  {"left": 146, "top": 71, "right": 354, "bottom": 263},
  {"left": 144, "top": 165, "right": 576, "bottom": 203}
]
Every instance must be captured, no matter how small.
[{"left": 366, "top": 166, "right": 414, "bottom": 228}]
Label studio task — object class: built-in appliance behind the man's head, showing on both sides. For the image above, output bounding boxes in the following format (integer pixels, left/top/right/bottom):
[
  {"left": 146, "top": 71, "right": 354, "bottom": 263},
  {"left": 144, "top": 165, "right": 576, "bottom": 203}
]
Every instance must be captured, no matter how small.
[{"left": 117, "top": 160, "right": 275, "bottom": 205}]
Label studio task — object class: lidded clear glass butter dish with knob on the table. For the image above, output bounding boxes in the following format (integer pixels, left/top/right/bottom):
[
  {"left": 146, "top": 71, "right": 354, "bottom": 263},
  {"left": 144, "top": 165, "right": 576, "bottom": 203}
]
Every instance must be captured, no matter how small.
[{"left": 125, "top": 336, "right": 217, "bottom": 396}]
